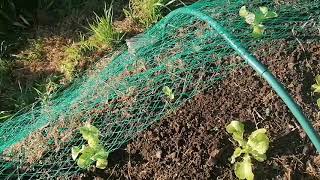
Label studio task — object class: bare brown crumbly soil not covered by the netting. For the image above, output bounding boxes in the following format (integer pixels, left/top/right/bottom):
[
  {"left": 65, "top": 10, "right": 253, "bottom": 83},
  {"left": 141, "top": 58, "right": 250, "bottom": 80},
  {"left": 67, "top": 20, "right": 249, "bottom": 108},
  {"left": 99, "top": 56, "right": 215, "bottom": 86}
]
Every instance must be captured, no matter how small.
[{"left": 83, "top": 42, "right": 320, "bottom": 179}]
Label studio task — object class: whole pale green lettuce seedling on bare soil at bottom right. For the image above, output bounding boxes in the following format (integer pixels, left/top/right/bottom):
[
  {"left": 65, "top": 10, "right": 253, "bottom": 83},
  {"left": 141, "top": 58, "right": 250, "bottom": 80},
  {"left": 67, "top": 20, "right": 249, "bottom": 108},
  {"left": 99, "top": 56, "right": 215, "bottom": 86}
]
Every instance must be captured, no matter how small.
[{"left": 226, "top": 121, "right": 269, "bottom": 180}]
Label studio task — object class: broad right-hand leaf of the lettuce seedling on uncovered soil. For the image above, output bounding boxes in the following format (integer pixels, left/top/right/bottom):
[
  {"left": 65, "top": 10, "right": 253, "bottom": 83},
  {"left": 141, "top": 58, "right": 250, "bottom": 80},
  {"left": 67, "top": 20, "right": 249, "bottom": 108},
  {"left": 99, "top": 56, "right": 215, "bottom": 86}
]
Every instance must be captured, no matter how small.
[{"left": 247, "top": 129, "right": 269, "bottom": 154}]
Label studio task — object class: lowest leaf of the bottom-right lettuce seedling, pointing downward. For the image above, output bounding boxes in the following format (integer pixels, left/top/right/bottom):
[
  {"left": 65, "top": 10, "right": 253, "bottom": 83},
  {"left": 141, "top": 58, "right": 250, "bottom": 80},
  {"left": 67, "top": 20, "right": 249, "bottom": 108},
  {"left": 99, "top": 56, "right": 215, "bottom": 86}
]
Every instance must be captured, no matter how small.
[{"left": 234, "top": 156, "right": 254, "bottom": 180}]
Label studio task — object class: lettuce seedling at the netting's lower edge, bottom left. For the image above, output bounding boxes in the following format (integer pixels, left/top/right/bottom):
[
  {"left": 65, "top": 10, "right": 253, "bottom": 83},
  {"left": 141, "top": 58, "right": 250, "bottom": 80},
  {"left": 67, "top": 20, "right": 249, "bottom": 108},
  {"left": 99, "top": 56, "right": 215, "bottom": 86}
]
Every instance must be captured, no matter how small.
[{"left": 71, "top": 124, "right": 109, "bottom": 169}]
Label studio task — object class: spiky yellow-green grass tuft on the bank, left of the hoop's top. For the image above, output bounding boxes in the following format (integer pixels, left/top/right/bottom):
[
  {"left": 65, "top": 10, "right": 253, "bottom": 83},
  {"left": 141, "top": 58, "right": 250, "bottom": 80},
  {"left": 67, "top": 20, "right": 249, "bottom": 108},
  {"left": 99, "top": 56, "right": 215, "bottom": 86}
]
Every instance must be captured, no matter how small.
[{"left": 89, "top": 6, "right": 121, "bottom": 48}]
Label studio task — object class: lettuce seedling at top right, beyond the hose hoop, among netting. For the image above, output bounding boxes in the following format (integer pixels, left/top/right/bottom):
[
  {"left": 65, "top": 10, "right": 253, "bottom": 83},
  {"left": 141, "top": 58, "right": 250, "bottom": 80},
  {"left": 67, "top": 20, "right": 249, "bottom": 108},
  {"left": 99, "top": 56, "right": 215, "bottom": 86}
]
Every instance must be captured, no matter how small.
[{"left": 239, "top": 6, "right": 278, "bottom": 38}]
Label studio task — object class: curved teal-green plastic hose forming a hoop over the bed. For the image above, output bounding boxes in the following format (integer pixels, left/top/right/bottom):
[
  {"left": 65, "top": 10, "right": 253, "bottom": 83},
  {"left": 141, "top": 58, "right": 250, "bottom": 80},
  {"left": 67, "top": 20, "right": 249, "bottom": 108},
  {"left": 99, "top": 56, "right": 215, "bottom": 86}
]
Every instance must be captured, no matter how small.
[{"left": 163, "top": 7, "right": 320, "bottom": 152}]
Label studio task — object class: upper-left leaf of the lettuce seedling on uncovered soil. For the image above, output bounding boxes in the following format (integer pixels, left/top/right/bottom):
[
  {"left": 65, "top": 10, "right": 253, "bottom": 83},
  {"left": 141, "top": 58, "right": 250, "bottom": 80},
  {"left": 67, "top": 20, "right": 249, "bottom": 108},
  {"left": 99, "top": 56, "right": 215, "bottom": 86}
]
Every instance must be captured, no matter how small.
[{"left": 226, "top": 121, "right": 245, "bottom": 146}]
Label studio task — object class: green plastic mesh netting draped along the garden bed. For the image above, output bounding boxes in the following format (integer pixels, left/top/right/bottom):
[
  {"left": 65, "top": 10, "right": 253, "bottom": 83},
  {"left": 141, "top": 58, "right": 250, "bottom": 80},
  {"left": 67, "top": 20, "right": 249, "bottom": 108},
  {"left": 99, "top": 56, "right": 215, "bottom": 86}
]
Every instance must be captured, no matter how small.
[{"left": 0, "top": 0, "right": 320, "bottom": 179}]
